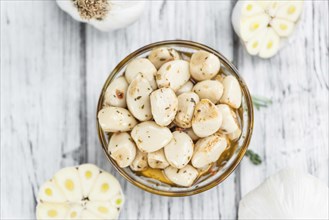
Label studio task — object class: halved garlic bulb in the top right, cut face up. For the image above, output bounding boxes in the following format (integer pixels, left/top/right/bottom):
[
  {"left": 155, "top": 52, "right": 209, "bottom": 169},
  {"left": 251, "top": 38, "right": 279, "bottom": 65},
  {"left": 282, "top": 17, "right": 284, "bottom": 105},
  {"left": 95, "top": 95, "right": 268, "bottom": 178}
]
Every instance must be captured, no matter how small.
[{"left": 232, "top": 0, "right": 303, "bottom": 58}]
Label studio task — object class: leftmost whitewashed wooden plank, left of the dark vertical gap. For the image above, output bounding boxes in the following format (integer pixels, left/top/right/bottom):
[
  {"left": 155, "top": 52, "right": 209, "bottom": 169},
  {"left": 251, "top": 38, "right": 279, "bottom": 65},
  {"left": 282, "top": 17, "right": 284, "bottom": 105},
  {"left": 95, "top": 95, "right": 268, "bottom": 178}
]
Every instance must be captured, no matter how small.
[{"left": 1, "top": 1, "right": 84, "bottom": 219}]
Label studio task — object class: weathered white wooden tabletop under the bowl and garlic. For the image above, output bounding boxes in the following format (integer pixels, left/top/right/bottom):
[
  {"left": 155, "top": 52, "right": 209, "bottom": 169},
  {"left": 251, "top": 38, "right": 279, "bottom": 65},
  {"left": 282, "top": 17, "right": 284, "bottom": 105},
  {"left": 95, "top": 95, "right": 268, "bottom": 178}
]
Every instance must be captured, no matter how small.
[{"left": 1, "top": 0, "right": 329, "bottom": 219}]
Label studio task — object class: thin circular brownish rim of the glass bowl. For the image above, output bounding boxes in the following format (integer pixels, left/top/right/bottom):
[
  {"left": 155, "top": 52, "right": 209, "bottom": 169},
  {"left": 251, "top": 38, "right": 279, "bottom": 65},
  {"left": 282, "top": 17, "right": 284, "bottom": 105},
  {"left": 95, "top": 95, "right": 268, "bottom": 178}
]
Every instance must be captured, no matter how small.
[{"left": 96, "top": 40, "right": 254, "bottom": 197}]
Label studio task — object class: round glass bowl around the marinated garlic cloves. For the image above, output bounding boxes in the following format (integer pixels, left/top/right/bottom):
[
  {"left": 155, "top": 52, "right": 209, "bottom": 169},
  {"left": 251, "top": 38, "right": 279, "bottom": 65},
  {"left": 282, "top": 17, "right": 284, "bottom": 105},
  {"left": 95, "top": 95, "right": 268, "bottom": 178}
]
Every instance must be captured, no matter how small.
[{"left": 96, "top": 40, "right": 254, "bottom": 197}]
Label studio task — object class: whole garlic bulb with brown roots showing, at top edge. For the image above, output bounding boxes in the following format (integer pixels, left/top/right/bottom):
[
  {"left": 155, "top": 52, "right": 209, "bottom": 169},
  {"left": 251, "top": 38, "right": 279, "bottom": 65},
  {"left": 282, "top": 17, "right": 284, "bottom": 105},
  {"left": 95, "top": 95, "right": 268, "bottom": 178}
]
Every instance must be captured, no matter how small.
[{"left": 56, "top": 0, "right": 145, "bottom": 31}]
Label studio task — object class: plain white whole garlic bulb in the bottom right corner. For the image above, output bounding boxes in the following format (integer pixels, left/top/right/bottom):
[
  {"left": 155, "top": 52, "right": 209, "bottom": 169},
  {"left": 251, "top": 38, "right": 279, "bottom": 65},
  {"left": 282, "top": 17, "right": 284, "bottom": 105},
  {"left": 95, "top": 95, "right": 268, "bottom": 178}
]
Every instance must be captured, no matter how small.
[{"left": 239, "top": 169, "right": 329, "bottom": 219}]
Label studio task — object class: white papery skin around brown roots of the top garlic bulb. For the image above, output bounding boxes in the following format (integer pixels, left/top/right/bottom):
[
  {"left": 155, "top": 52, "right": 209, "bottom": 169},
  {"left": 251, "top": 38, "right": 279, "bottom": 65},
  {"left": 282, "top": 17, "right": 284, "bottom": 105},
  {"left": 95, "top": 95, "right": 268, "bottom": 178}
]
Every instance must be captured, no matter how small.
[{"left": 56, "top": 0, "right": 146, "bottom": 32}]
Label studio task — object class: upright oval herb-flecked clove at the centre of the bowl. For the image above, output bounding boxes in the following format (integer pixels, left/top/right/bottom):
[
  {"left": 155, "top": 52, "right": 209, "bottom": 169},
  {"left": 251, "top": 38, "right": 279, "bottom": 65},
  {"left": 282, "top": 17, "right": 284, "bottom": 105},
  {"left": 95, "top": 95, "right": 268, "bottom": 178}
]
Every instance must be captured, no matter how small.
[{"left": 150, "top": 88, "right": 178, "bottom": 126}]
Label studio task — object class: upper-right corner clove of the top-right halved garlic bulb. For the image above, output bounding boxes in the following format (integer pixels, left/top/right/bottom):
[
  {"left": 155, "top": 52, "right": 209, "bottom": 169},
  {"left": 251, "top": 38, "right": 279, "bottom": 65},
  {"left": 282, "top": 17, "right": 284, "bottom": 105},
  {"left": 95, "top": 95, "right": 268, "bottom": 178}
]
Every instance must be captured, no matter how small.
[{"left": 275, "top": 1, "right": 304, "bottom": 22}]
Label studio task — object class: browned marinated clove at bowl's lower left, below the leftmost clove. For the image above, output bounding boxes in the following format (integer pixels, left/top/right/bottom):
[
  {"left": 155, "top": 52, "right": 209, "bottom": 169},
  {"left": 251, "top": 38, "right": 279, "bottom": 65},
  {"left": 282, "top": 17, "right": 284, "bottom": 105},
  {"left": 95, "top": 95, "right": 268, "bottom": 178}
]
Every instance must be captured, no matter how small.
[{"left": 108, "top": 132, "right": 136, "bottom": 167}]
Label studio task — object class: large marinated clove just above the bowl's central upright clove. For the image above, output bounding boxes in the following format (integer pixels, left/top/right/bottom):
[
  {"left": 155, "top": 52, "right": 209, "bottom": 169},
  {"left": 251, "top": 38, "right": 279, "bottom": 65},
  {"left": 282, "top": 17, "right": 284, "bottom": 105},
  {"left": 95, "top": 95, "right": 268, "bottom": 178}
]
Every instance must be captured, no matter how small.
[{"left": 155, "top": 60, "right": 190, "bottom": 92}]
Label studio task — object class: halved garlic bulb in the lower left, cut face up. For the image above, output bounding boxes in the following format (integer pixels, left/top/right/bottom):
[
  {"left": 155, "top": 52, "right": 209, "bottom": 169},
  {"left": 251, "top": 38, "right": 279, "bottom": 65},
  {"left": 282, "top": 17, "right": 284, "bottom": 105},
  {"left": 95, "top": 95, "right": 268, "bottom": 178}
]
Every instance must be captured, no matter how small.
[{"left": 36, "top": 164, "right": 124, "bottom": 219}]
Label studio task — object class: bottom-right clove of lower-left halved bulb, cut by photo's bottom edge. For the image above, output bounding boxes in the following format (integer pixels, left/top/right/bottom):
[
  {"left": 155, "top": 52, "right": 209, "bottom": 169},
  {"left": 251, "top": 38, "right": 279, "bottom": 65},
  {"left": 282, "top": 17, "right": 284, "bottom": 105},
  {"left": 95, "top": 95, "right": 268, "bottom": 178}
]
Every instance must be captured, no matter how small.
[{"left": 86, "top": 201, "right": 119, "bottom": 219}]
